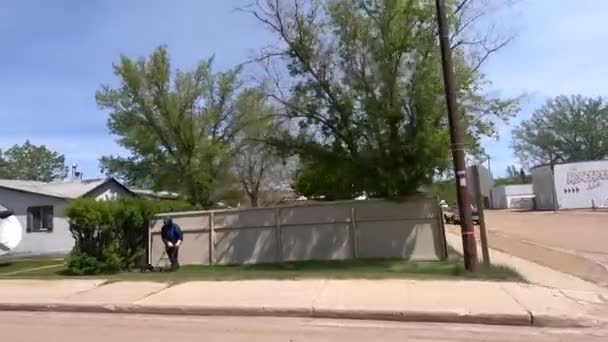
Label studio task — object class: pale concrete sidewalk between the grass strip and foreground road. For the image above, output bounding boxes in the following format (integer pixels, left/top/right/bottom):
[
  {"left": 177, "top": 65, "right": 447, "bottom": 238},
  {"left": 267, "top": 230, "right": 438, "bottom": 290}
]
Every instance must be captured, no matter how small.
[{"left": 0, "top": 280, "right": 608, "bottom": 327}]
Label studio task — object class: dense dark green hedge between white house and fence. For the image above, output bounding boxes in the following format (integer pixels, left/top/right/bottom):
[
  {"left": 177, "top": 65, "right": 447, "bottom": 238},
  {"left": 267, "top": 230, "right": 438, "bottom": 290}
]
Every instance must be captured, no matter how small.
[{"left": 66, "top": 199, "right": 194, "bottom": 275}]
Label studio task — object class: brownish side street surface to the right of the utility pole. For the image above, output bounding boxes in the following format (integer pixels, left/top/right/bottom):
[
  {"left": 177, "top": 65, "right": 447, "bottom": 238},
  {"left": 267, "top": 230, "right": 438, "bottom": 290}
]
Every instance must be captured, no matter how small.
[{"left": 448, "top": 210, "right": 608, "bottom": 286}]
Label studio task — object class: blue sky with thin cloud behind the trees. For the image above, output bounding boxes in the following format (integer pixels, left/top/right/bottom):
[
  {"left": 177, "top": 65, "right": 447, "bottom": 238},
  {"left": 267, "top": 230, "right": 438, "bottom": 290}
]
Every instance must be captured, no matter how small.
[{"left": 0, "top": 0, "right": 608, "bottom": 177}]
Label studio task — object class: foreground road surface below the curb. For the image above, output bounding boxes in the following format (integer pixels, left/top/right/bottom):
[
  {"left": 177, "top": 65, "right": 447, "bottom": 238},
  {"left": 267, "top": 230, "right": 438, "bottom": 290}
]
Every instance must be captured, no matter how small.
[{"left": 0, "top": 312, "right": 608, "bottom": 342}]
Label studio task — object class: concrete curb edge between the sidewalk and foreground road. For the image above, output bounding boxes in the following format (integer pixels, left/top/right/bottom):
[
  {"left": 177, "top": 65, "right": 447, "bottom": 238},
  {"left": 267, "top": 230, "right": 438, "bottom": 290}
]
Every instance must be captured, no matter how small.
[{"left": 0, "top": 303, "right": 606, "bottom": 328}]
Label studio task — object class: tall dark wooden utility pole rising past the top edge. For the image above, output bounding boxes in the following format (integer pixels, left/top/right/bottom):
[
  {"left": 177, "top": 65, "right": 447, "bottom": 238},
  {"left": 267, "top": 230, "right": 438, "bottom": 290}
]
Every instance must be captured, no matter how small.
[{"left": 435, "top": 0, "right": 477, "bottom": 272}]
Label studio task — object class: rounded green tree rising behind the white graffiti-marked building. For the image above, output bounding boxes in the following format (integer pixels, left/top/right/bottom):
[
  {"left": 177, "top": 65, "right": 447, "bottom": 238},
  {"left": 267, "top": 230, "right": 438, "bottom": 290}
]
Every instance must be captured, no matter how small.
[{"left": 512, "top": 95, "right": 608, "bottom": 166}]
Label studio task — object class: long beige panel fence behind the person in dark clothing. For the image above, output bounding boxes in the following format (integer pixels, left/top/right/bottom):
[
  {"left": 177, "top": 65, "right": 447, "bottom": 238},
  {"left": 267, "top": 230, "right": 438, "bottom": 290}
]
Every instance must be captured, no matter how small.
[{"left": 149, "top": 197, "right": 447, "bottom": 266}]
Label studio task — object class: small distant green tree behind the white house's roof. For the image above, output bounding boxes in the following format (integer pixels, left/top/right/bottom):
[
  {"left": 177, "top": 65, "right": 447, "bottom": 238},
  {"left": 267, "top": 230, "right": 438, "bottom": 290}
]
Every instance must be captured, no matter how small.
[{"left": 0, "top": 140, "right": 67, "bottom": 182}]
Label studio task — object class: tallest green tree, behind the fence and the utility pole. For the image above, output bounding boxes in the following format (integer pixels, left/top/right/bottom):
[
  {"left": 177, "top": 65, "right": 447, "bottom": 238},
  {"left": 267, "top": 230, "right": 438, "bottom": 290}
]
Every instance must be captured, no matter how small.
[{"left": 252, "top": 0, "right": 516, "bottom": 199}]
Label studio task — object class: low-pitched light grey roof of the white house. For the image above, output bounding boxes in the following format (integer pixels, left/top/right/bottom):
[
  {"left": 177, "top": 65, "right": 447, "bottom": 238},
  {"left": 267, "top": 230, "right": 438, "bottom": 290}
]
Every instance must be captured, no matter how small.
[{"left": 0, "top": 178, "right": 130, "bottom": 199}]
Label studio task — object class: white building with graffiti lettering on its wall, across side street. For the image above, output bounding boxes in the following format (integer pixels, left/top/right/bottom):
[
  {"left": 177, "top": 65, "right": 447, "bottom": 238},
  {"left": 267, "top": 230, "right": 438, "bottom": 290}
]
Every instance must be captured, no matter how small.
[{"left": 531, "top": 160, "right": 608, "bottom": 210}]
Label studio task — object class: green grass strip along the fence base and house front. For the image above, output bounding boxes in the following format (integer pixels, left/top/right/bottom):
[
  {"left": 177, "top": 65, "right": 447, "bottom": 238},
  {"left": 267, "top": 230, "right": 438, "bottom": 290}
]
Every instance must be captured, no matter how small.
[{"left": 0, "top": 251, "right": 524, "bottom": 282}]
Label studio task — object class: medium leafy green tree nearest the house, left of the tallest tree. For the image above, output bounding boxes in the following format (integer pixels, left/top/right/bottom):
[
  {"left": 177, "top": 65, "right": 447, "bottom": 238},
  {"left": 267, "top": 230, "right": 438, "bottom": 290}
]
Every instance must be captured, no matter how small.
[{"left": 96, "top": 47, "right": 252, "bottom": 207}]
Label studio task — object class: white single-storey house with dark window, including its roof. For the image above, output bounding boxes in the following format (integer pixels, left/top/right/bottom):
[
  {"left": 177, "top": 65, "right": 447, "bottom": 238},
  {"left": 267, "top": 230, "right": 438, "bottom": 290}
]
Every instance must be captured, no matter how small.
[{"left": 0, "top": 178, "right": 135, "bottom": 255}]
